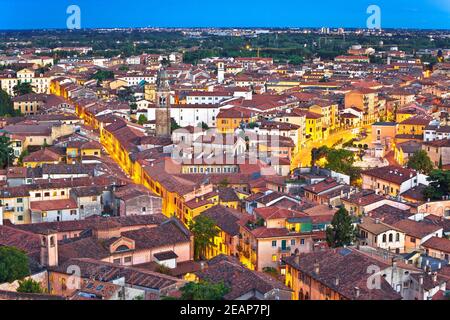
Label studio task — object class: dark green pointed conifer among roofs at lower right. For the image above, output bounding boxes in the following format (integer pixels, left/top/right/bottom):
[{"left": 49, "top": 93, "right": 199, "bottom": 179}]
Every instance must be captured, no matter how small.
[{"left": 326, "top": 208, "right": 356, "bottom": 248}]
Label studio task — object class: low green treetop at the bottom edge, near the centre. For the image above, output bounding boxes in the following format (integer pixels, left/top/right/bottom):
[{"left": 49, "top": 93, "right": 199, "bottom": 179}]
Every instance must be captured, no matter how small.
[{"left": 180, "top": 281, "right": 230, "bottom": 300}]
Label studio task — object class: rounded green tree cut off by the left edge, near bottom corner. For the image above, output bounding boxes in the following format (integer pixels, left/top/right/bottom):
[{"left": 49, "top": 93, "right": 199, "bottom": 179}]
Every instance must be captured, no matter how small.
[{"left": 0, "top": 246, "right": 30, "bottom": 283}]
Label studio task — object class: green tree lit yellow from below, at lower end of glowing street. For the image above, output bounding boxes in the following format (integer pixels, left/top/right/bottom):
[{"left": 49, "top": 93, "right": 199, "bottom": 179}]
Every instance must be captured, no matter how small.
[{"left": 189, "top": 215, "right": 219, "bottom": 260}]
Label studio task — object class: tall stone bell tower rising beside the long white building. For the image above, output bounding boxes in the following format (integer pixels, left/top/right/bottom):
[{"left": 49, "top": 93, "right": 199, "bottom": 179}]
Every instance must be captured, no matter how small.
[{"left": 155, "top": 69, "right": 171, "bottom": 137}]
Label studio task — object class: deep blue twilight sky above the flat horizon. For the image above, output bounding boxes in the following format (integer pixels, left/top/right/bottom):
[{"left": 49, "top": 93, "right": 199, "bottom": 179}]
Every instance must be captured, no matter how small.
[{"left": 0, "top": 0, "right": 450, "bottom": 29}]
